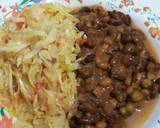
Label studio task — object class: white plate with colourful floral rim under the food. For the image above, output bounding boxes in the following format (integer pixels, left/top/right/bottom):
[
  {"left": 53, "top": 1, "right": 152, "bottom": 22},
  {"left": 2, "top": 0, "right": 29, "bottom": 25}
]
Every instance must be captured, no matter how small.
[{"left": 0, "top": 0, "right": 160, "bottom": 128}]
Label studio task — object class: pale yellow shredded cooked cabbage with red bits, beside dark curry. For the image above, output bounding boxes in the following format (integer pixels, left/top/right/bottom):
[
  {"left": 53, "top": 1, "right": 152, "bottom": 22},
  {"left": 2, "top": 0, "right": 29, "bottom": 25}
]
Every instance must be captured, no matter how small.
[{"left": 0, "top": 4, "right": 83, "bottom": 128}]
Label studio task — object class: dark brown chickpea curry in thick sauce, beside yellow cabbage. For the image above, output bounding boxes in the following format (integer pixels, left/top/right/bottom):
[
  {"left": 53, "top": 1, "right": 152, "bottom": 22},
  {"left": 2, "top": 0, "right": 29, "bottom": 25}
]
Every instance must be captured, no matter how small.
[{"left": 70, "top": 6, "right": 160, "bottom": 128}]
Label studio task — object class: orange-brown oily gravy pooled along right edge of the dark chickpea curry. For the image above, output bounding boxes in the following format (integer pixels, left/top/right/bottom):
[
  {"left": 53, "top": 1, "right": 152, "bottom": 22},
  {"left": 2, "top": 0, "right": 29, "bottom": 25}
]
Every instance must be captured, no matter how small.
[{"left": 125, "top": 40, "right": 160, "bottom": 128}]
